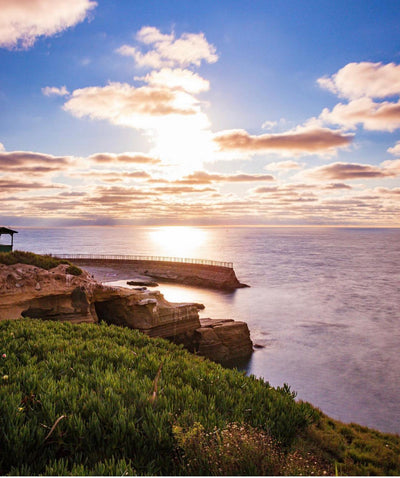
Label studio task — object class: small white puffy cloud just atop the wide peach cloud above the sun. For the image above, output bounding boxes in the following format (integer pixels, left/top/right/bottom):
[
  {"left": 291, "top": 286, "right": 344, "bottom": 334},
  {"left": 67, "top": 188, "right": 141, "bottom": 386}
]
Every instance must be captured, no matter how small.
[{"left": 135, "top": 68, "right": 210, "bottom": 93}]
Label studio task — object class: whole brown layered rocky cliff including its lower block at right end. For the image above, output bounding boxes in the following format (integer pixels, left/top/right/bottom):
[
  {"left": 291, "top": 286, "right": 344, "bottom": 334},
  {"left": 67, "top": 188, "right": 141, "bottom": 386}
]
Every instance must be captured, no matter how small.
[{"left": 0, "top": 264, "right": 252, "bottom": 362}]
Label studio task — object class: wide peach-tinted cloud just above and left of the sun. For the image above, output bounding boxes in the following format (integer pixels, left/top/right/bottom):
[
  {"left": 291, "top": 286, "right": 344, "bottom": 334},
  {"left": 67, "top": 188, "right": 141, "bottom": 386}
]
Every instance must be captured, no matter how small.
[{"left": 64, "top": 83, "right": 206, "bottom": 129}]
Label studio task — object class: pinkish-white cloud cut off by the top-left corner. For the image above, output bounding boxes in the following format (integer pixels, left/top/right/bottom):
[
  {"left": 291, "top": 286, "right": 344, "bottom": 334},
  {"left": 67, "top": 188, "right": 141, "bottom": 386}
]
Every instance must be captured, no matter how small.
[{"left": 0, "top": 0, "right": 97, "bottom": 49}]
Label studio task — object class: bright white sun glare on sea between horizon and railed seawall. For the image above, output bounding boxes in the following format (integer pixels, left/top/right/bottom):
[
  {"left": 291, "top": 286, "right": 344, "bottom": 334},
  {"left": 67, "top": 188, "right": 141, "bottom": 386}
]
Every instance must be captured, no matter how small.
[{"left": 149, "top": 226, "right": 208, "bottom": 258}]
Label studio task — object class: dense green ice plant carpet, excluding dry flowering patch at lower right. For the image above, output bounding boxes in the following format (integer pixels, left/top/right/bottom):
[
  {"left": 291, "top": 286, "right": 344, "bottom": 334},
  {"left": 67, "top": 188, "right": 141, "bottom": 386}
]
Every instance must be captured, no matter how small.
[{"left": 0, "top": 319, "right": 308, "bottom": 475}]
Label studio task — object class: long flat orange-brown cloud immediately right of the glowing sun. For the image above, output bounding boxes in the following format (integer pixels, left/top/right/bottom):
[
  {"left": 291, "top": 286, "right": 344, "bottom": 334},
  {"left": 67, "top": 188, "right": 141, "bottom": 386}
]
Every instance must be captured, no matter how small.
[{"left": 214, "top": 126, "right": 352, "bottom": 155}]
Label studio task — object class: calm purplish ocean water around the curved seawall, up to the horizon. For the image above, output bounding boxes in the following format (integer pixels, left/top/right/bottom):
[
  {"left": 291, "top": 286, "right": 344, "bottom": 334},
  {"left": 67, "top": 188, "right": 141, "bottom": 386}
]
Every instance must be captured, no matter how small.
[{"left": 7, "top": 227, "right": 400, "bottom": 433}]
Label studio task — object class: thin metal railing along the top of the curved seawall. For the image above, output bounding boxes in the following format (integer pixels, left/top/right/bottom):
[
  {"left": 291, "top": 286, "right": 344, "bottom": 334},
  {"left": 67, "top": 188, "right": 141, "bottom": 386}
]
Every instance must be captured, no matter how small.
[{"left": 52, "top": 254, "right": 233, "bottom": 269}]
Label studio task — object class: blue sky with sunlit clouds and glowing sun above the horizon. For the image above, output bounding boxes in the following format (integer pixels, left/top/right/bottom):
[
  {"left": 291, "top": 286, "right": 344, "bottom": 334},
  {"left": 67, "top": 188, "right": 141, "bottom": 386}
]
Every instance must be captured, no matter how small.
[{"left": 0, "top": 0, "right": 400, "bottom": 227}]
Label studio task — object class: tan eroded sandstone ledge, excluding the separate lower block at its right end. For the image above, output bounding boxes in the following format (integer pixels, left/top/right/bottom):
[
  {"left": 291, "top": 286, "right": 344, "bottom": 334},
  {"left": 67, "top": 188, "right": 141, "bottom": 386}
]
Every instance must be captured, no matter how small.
[{"left": 0, "top": 264, "right": 200, "bottom": 337}]
